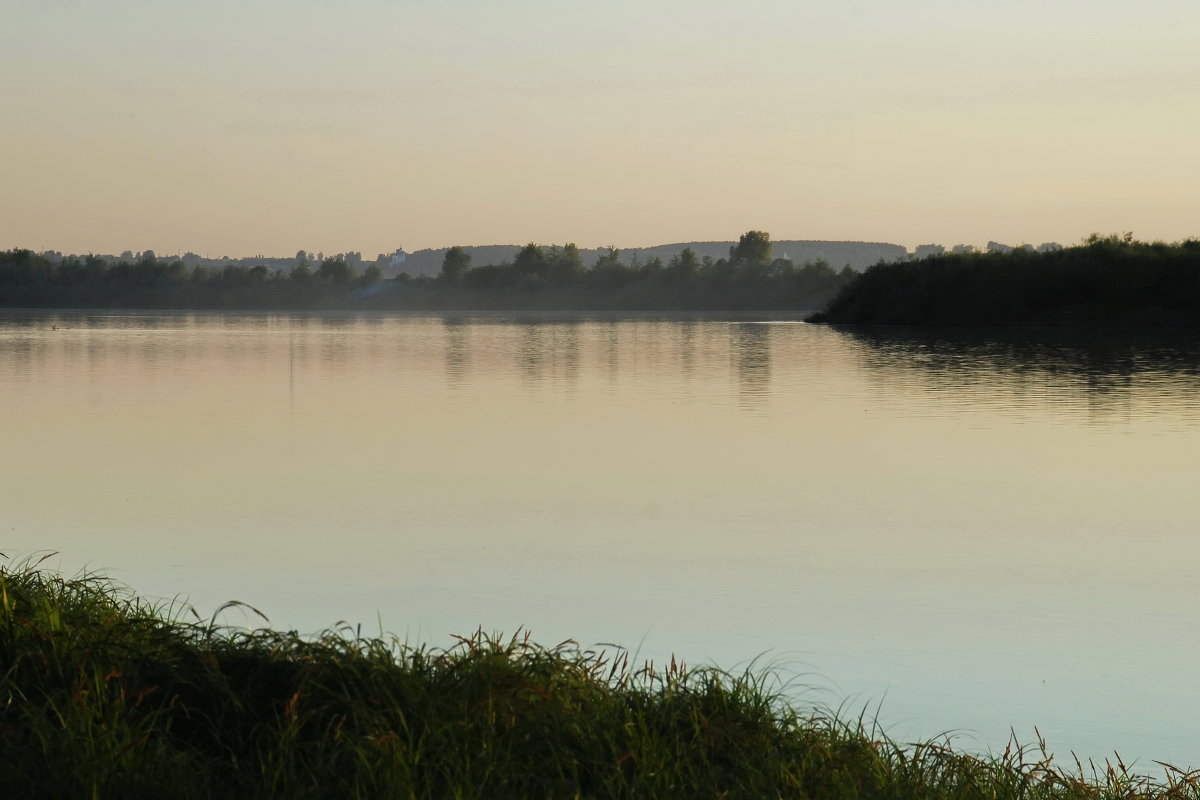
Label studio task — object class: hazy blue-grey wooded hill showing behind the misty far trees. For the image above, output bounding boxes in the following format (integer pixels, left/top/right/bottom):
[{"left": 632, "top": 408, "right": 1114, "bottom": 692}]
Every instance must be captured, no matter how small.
[{"left": 384, "top": 240, "right": 908, "bottom": 277}]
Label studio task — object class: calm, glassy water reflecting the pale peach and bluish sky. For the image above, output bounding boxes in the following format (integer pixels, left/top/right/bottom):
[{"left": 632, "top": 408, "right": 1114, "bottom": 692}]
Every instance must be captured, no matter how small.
[{"left": 0, "top": 312, "right": 1200, "bottom": 769}]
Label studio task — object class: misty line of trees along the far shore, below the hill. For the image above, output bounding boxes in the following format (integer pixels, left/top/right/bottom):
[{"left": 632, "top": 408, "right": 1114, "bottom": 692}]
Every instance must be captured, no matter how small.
[{"left": 0, "top": 231, "right": 857, "bottom": 311}]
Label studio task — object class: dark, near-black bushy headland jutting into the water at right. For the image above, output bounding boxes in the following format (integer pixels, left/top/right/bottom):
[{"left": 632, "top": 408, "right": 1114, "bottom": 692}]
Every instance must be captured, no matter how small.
[{"left": 809, "top": 234, "right": 1200, "bottom": 326}]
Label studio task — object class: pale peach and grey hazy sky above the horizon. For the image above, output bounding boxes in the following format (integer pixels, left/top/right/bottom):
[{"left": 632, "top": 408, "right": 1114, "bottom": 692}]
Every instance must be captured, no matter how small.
[{"left": 0, "top": 0, "right": 1200, "bottom": 257}]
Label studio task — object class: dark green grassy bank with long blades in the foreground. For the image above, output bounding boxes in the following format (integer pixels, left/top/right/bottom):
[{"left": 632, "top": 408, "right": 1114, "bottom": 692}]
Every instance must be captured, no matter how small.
[{"left": 0, "top": 564, "right": 1200, "bottom": 800}]
